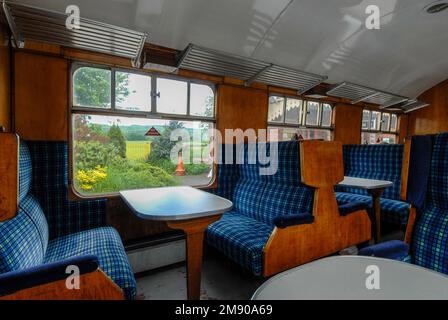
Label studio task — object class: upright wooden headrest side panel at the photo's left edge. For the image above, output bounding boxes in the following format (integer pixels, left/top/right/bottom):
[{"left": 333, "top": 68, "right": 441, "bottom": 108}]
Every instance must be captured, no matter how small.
[{"left": 0, "top": 133, "right": 19, "bottom": 222}]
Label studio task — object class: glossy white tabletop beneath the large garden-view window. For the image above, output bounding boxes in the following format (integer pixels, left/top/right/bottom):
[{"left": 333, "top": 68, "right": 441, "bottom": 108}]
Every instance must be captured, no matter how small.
[{"left": 120, "top": 187, "right": 233, "bottom": 221}]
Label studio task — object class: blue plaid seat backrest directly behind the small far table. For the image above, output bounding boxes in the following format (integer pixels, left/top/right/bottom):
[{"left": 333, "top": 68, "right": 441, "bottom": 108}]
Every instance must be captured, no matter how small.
[{"left": 338, "top": 144, "right": 404, "bottom": 200}]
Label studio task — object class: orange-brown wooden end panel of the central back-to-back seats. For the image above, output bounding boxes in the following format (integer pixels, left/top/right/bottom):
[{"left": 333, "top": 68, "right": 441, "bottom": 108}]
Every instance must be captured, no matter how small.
[{"left": 264, "top": 141, "right": 371, "bottom": 277}]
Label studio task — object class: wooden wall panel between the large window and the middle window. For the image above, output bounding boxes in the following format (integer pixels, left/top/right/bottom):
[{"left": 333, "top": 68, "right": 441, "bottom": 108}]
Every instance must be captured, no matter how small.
[{"left": 217, "top": 85, "right": 268, "bottom": 141}]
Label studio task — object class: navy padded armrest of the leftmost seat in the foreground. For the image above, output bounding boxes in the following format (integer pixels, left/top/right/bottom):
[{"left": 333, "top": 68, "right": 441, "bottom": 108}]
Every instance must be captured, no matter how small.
[{"left": 0, "top": 255, "right": 98, "bottom": 296}]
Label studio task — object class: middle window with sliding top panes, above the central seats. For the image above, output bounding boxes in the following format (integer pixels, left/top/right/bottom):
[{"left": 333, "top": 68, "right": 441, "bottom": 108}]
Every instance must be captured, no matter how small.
[{"left": 268, "top": 95, "right": 333, "bottom": 141}]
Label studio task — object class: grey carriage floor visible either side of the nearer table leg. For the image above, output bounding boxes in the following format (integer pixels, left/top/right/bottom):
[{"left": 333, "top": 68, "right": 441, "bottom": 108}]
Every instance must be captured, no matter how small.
[{"left": 137, "top": 251, "right": 264, "bottom": 300}]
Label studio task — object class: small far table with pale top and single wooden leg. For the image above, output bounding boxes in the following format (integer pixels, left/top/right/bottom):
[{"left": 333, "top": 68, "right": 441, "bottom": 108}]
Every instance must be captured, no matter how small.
[{"left": 339, "top": 177, "right": 394, "bottom": 242}]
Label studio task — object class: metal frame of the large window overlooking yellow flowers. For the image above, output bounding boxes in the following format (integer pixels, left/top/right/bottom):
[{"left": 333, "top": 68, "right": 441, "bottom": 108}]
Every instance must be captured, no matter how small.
[{"left": 68, "top": 61, "right": 217, "bottom": 199}]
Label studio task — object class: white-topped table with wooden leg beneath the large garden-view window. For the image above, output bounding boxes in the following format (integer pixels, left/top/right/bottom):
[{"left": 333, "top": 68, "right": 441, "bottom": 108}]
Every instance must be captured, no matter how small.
[{"left": 120, "top": 187, "right": 233, "bottom": 300}]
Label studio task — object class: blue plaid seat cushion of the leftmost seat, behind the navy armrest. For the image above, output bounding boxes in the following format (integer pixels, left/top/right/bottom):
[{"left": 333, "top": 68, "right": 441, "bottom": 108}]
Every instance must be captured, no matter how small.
[{"left": 44, "top": 227, "right": 137, "bottom": 299}]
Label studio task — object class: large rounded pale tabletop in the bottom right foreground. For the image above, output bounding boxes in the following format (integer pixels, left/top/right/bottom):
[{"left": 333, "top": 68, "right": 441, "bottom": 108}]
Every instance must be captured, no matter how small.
[{"left": 252, "top": 256, "right": 448, "bottom": 300}]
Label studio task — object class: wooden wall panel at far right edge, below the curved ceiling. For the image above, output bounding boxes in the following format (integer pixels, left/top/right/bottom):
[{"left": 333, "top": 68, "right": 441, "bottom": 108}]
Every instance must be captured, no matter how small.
[{"left": 408, "top": 80, "right": 448, "bottom": 135}]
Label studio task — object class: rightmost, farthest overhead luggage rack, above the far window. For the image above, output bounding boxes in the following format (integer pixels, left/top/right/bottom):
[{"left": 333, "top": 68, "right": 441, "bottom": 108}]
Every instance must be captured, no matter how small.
[{"left": 327, "top": 82, "right": 429, "bottom": 112}]
